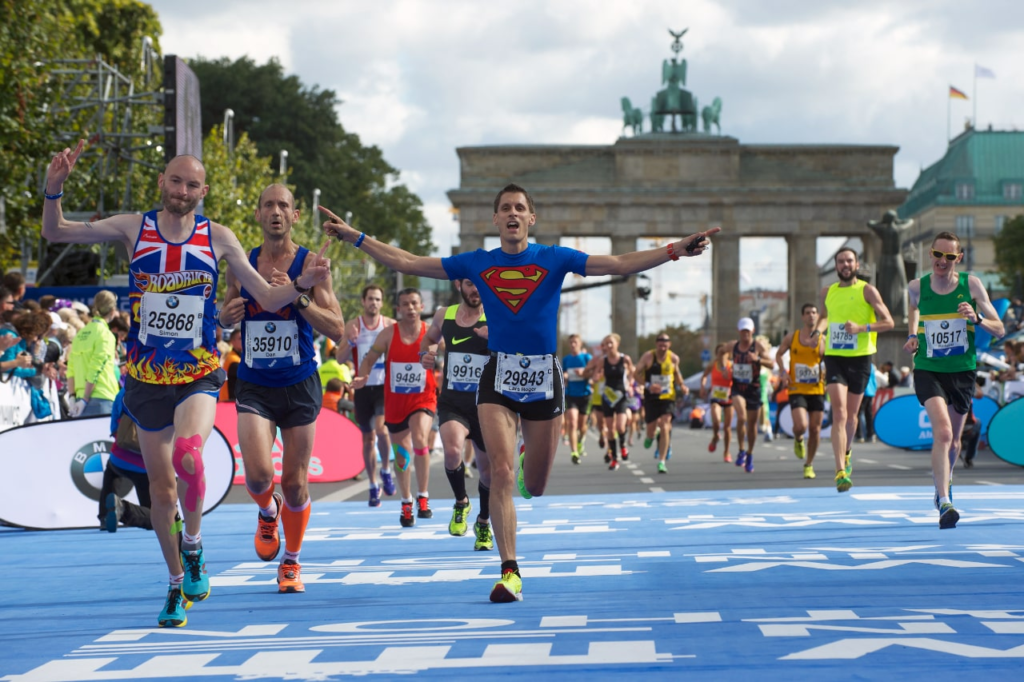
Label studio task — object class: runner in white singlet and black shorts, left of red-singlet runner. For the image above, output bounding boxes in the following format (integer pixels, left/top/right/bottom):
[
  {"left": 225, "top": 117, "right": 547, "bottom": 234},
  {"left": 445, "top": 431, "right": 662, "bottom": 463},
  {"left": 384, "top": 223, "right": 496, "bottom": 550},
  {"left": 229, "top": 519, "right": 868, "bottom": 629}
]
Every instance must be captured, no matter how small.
[{"left": 334, "top": 284, "right": 394, "bottom": 507}]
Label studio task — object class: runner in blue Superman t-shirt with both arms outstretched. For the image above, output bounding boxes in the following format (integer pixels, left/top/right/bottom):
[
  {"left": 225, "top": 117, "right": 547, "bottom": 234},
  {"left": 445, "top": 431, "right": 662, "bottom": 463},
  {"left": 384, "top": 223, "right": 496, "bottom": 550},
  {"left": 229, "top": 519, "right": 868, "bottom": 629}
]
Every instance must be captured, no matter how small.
[{"left": 319, "top": 184, "right": 721, "bottom": 603}]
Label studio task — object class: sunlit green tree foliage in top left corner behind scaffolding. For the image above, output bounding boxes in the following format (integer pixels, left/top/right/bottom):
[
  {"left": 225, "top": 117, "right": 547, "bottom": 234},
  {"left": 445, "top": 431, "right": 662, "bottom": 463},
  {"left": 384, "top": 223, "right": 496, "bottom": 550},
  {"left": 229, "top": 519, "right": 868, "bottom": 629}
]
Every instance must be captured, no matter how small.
[{"left": 0, "top": 0, "right": 161, "bottom": 276}]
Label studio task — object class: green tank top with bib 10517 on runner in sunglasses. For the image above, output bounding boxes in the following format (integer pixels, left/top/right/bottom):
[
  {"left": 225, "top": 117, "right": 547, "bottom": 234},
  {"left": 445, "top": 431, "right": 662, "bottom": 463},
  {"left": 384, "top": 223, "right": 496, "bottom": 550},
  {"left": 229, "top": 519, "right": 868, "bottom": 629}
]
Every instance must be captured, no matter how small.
[{"left": 913, "top": 272, "right": 978, "bottom": 373}]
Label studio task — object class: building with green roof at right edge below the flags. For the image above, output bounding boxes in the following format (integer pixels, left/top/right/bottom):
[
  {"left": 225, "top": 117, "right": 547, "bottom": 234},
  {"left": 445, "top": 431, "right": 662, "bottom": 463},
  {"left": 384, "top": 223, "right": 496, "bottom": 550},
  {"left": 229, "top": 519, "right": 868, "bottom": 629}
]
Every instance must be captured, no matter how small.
[{"left": 899, "top": 128, "right": 1024, "bottom": 290}]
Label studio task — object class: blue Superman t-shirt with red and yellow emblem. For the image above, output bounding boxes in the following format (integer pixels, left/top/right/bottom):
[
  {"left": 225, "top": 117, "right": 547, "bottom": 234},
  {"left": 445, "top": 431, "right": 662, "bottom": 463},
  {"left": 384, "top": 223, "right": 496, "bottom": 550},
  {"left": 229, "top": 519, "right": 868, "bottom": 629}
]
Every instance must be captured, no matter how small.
[{"left": 441, "top": 244, "right": 587, "bottom": 355}]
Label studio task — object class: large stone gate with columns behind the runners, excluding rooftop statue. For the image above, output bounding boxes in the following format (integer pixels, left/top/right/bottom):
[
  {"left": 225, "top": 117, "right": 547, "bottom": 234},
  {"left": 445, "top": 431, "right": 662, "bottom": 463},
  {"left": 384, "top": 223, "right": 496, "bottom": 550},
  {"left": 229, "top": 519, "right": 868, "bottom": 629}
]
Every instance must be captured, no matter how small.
[{"left": 449, "top": 132, "right": 906, "bottom": 356}]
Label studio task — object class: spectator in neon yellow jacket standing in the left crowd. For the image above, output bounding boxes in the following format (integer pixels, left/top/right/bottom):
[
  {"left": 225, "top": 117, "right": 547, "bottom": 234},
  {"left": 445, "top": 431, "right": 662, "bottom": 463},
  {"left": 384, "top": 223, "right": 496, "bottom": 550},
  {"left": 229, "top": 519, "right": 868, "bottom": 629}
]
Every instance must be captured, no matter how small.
[{"left": 68, "top": 290, "right": 121, "bottom": 418}]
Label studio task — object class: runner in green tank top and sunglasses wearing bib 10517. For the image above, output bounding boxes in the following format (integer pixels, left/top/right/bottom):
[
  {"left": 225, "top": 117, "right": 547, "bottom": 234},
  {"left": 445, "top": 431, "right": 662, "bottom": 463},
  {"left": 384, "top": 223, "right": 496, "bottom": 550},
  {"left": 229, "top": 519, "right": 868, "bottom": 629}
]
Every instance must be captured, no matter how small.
[{"left": 903, "top": 232, "right": 1006, "bottom": 529}]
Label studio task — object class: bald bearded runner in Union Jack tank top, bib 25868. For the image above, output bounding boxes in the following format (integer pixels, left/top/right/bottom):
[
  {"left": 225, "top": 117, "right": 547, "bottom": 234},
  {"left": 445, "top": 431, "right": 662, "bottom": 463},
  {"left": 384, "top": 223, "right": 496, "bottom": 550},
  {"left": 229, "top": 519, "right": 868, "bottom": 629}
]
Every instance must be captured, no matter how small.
[{"left": 42, "top": 140, "right": 330, "bottom": 628}]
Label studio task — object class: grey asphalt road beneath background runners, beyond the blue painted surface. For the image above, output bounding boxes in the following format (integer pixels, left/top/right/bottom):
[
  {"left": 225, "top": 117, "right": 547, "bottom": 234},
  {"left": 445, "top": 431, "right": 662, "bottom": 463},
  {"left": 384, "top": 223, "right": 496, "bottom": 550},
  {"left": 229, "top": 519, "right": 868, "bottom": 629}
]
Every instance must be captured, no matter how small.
[{"left": 225, "top": 427, "right": 1024, "bottom": 507}]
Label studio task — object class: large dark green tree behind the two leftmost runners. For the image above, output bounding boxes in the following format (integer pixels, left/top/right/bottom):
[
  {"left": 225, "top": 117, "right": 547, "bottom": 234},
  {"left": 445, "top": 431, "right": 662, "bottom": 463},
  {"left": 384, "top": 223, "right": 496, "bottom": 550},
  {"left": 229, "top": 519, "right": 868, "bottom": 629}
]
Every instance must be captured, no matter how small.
[{"left": 188, "top": 57, "right": 434, "bottom": 315}]
